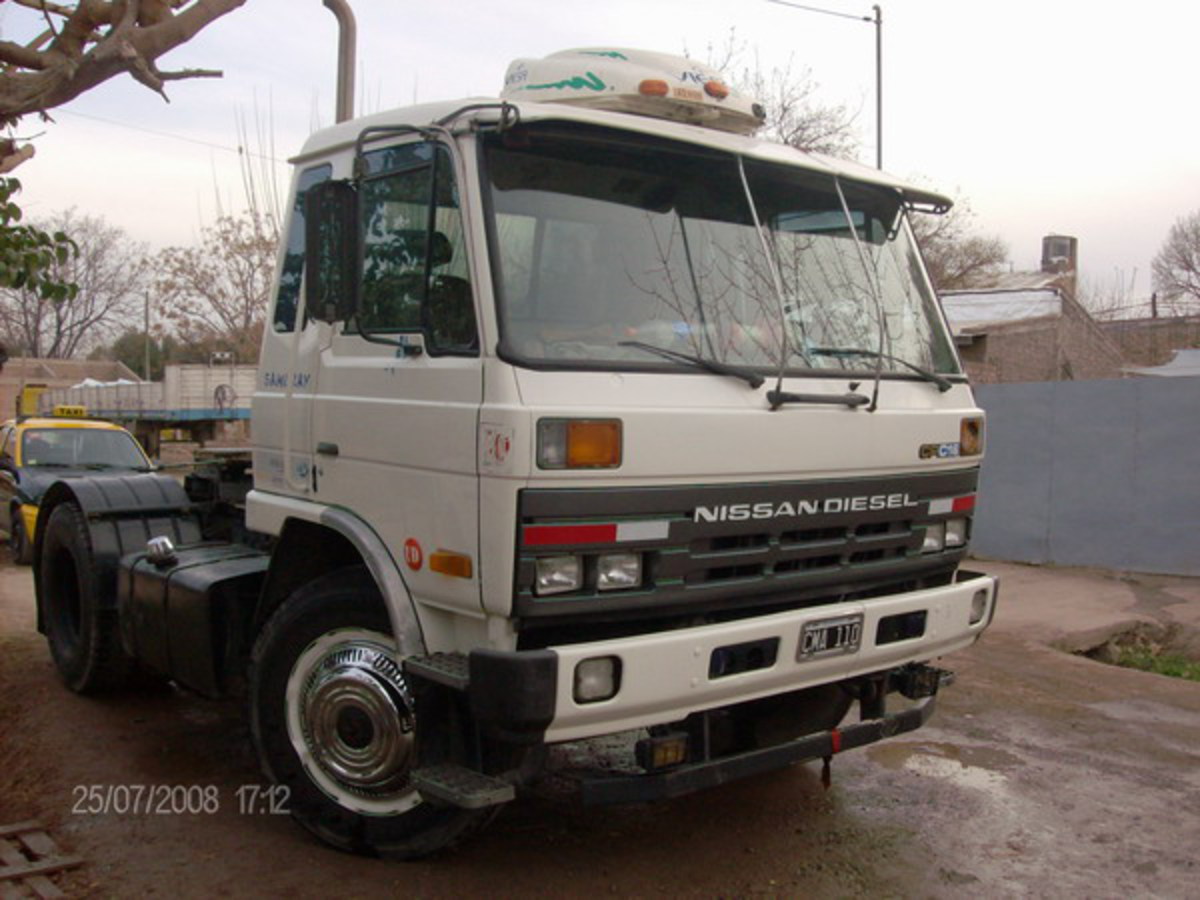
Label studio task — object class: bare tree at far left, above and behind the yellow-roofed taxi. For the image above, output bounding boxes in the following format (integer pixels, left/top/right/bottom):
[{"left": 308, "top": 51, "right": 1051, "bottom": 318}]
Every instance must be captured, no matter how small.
[{"left": 0, "top": 210, "right": 146, "bottom": 359}]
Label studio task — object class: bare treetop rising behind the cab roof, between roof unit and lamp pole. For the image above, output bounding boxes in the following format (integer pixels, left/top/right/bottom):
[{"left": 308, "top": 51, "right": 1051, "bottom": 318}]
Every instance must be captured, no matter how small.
[{"left": 707, "top": 29, "right": 859, "bottom": 158}]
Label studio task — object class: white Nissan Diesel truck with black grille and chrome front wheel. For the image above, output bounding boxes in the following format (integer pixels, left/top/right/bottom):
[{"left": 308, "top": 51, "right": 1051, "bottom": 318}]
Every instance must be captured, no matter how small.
[{"left": 35, "top": 48, "right": 997, "bottom": 858}]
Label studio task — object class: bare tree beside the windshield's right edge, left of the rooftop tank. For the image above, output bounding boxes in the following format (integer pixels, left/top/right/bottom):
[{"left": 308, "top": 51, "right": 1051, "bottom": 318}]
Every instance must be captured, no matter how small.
[{"left": 912, "top": 202, "right": 1008, "bottom": 290}]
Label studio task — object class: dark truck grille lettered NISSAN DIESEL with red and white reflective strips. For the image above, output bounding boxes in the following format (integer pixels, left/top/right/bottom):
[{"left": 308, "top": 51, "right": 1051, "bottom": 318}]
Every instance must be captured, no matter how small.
[{"left": 515, "top": 468, "right": 978, "bottom": 641}]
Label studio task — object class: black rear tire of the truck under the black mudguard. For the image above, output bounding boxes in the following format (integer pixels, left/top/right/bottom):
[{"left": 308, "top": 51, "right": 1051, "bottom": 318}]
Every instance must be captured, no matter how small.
[{"left": 40, "top": 503, "right": 133, "bottom": 694}]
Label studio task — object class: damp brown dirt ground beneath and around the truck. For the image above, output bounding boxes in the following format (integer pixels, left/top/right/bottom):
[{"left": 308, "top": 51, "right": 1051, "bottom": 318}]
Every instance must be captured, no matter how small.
[{"left": 0, "top": 562, "right": 1200, "bottom": 898}]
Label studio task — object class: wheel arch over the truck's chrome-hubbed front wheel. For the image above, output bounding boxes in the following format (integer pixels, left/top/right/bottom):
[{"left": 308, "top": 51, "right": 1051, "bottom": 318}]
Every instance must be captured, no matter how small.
[{"left": 254, "top": 508, "right": 425, "bottom": 655}]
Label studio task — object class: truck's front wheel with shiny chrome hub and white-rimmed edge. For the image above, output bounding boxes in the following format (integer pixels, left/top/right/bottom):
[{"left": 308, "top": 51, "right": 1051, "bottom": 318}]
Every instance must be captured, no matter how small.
[{"left": 250, "top": 566, "right": 486, "bottom": 859}]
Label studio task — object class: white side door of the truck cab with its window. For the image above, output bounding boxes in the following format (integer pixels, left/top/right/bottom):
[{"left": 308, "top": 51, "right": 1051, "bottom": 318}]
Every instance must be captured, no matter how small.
[{"left": 311, "top": 140, "right": 482, "bottom": 610}]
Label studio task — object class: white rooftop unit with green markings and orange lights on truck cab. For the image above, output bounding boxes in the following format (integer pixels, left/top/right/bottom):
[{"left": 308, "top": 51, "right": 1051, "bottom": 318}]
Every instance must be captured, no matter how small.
[{"left": 500, "top": 47, "right": 766, "bottom": 134}]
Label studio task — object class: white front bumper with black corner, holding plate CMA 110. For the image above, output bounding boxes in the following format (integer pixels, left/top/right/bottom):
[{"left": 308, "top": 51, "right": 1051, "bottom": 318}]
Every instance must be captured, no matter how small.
[{"left": 404, "top": 572, "right": 997, "bottom": 743}]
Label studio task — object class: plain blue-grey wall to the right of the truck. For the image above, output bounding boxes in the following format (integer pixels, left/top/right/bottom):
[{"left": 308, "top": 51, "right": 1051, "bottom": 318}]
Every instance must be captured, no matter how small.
[{"left": 973, "top": 378, "right": 1200, "bottom": 575}]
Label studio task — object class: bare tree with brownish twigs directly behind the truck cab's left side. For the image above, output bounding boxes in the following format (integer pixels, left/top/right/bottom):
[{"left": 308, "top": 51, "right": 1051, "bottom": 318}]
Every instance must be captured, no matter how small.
[{"left": 156, "top": 211, "right": 278, "bottom": 359}]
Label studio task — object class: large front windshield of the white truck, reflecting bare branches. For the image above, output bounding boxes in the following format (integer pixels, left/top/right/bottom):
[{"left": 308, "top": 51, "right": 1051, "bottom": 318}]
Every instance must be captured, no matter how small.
[{"left": 485, "top": 125, "right": 959, "bottom": 374}]
